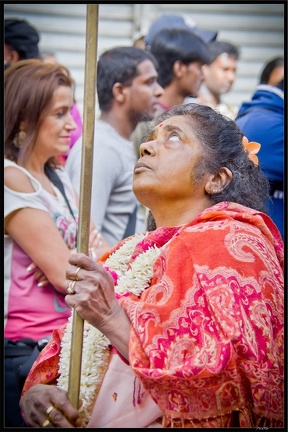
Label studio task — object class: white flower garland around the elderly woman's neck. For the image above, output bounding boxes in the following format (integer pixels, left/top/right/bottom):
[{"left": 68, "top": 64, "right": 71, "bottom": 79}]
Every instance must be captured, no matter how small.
[{"left": 57, "top": 234, "right": 160, "bottom": 427}]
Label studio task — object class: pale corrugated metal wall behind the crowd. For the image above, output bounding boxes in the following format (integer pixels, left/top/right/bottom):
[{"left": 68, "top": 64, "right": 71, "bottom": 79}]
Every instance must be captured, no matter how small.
[{"left": 4, "top": 2, "right": 287, "bottom": 115}]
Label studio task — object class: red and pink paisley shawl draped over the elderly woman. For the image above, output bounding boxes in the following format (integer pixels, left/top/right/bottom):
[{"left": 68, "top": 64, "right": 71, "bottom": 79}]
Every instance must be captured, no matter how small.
[{"left": 23, "top": 202, "right": 284, "bottom": 428}]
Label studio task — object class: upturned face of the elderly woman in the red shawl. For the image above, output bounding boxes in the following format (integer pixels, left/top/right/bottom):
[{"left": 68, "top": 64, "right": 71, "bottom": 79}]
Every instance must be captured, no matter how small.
[{"left": 133, "top": 116, "right": 205, "bottom": 207}]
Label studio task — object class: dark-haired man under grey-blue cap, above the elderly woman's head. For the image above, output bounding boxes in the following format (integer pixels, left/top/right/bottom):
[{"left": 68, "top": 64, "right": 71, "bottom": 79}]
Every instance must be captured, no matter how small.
[{"left": 132, "top": 14, "right": 217, "bottom": 174}]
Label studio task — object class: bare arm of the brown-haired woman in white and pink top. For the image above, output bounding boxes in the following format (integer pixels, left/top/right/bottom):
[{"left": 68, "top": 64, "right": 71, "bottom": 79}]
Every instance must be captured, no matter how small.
[{"left": 4, "top": 167, "right": 106, "bottom": 294}]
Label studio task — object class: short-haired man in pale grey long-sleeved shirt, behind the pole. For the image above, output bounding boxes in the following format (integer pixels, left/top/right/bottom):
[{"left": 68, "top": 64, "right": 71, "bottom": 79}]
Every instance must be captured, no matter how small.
[{"left": 65, "top": 47, "right": 163, "bottom": 256}]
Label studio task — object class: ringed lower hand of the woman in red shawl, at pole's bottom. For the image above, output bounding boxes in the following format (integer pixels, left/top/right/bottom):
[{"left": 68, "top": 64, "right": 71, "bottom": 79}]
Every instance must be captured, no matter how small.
[{"left": 19, "top": 384, "right": 81, "bottom": 428}]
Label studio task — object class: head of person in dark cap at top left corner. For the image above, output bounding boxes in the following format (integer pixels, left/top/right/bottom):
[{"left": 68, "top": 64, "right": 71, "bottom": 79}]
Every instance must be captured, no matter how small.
[{"left": 4, "top": 18, "right": 40, "bottom": 68}]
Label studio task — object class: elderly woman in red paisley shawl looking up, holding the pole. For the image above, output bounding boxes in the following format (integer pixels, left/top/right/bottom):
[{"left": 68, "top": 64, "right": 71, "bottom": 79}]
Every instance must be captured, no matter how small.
[{"left": 20, "top": 104, "right": 284, "bottom": 428}]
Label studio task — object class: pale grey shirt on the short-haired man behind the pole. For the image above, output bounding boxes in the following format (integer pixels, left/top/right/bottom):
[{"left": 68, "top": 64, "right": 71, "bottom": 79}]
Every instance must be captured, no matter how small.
[{"left": 65, "top": 119, "right": 145, "bottom": 246}]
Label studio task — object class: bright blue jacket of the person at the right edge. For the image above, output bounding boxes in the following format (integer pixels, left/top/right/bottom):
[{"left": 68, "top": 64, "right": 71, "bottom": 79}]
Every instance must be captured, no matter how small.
[{"left": 235, "top": 80, "right": 284, "bottom": 238}]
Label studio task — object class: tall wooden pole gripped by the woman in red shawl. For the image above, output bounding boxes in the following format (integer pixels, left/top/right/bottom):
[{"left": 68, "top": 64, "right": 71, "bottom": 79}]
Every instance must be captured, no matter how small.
[{"left": 68, "top": 3, "right": 98, "bottom": 409}]
